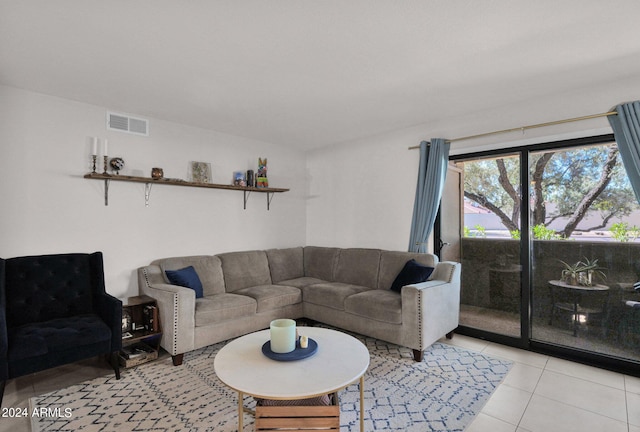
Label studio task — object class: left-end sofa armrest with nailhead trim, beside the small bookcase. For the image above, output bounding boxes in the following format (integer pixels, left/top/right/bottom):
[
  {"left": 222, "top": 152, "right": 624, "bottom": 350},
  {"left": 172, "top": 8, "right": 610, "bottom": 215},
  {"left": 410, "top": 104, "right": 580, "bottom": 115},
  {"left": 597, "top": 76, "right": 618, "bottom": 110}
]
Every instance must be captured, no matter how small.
[{"left": 138, "top": 265, "right": 196, "bottom": 356}]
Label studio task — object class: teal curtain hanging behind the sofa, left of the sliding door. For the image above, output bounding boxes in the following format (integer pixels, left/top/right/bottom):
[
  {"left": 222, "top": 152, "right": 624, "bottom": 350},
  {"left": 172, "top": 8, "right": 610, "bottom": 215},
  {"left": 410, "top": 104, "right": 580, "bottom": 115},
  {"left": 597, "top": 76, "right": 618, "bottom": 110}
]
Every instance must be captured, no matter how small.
[{"left": 409, "top": 138, "right": 450, "bottom": 253}]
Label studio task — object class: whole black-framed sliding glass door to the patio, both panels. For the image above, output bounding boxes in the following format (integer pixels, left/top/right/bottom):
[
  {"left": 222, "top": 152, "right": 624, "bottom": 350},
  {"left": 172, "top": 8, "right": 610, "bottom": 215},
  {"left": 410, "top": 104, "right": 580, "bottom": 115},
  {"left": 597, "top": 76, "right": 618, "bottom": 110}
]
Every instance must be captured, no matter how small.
[{"left": 436, "top": 135, "right": 640, "bottom": 369}]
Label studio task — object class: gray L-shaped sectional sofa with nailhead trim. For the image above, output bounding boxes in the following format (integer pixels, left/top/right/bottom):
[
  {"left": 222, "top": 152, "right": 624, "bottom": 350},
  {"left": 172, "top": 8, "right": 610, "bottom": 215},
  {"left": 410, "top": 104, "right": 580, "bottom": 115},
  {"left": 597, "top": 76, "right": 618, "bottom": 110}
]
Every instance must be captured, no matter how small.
[{"left": 138, "top": 246, "right": 460, "bottom": 365}]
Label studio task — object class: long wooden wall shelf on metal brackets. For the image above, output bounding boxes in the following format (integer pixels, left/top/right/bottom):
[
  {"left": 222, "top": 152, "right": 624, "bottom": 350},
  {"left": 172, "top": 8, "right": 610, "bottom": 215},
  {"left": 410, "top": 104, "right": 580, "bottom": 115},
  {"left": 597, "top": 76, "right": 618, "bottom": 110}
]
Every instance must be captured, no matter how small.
[{"left": 84, "top": 173, "right": 289, "bottom": 210}]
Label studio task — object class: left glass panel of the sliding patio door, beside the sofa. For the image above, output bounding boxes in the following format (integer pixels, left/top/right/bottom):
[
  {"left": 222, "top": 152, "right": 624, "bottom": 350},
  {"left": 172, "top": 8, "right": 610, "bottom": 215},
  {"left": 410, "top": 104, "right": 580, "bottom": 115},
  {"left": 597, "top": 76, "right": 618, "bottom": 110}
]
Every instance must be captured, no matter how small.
[{"left": 448, "top": 153, "right": 522, "bottom": 338}]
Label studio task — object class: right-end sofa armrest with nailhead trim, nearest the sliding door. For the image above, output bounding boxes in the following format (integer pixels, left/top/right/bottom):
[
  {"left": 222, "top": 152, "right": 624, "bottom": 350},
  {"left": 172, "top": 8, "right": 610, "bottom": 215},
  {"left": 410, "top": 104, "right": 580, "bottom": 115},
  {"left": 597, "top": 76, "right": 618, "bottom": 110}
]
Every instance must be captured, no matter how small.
[{"left": 401, "top": 262, "right": 460, "bottom": 351}]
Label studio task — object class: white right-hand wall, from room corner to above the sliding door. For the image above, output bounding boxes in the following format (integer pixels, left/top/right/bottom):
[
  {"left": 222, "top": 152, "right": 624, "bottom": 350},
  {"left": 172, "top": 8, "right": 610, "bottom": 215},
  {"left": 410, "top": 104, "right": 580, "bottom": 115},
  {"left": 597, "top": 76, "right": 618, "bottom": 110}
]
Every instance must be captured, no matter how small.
[{"left": 307, "top": 77, "right": 640, "bottom": 250}]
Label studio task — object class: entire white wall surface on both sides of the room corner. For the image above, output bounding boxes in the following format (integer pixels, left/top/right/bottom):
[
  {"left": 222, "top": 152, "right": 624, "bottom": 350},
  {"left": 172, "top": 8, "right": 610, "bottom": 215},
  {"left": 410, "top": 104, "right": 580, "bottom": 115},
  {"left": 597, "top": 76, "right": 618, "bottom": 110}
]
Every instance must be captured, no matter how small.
[{"left": 0, "top": 77, "right": 640, "bottom": 298}]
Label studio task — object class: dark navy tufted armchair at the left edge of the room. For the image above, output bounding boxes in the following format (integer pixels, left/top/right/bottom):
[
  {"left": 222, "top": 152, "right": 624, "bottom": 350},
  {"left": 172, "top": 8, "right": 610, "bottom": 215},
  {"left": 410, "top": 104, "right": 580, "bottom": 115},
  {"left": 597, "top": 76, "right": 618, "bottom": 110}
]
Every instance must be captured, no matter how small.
[{"left": 0, "top": 252, "right": 122, "bottom": 404}]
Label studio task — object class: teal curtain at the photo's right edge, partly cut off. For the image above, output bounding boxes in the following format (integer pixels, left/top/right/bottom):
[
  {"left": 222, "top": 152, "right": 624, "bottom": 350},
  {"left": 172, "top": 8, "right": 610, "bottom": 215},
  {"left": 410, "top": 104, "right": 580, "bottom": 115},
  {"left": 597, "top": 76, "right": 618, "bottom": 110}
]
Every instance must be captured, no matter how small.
[{"left": 609, "top": 101, "right": 640, "bottom": 203}]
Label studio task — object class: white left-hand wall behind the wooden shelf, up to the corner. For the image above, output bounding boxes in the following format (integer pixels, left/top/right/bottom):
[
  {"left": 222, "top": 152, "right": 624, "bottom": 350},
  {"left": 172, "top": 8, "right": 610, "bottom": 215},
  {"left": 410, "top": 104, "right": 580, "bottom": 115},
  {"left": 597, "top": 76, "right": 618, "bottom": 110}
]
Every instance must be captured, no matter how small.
[{"left": 0, "top": 86, "right": 306, "bottom": 298}]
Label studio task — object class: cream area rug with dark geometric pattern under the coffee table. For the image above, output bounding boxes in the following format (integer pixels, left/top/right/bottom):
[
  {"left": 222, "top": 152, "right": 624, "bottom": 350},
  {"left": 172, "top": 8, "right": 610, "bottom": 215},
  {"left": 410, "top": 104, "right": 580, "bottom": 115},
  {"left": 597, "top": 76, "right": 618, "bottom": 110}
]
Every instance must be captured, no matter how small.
[{"left": 30, "top": 334, "right": 511, "bottom": 432}]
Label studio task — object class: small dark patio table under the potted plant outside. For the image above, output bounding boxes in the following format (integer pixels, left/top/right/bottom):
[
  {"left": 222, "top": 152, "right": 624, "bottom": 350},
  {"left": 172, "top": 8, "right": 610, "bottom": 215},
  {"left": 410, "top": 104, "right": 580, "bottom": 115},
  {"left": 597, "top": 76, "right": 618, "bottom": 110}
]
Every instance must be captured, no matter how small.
[{"left": 548, "top": 280, "right": 609, "bottom": 337}]
